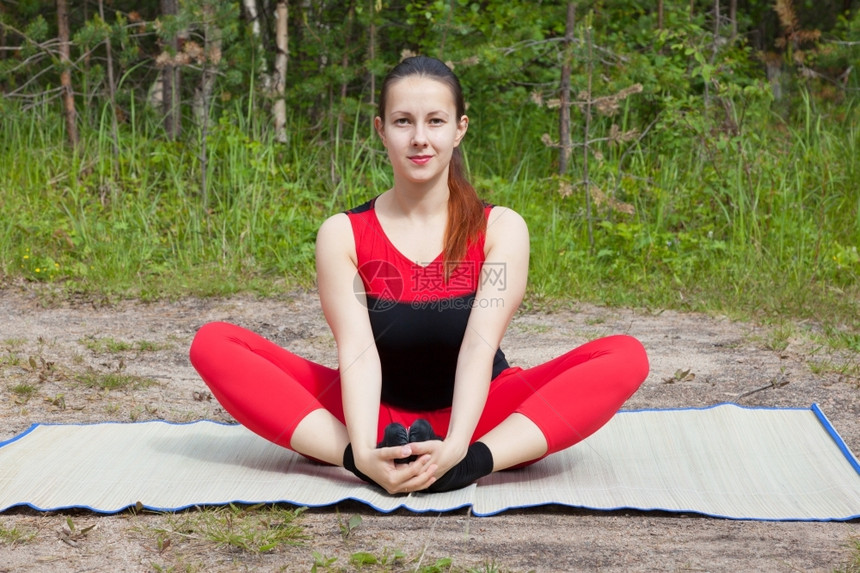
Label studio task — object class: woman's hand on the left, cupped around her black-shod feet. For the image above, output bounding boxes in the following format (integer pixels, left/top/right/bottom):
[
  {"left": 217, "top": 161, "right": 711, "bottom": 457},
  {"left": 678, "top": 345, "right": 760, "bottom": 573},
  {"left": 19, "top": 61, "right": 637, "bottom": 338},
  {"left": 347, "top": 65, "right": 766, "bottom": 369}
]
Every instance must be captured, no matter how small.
[{"left": 353, "top": 444, "right": 436, "bottom": 494}]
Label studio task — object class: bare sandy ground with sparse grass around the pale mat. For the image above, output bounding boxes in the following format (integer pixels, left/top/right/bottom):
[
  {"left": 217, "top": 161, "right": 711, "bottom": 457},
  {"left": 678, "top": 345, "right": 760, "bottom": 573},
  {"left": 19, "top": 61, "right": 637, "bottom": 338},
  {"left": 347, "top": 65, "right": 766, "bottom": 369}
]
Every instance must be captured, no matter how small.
[{"left": 0, "top": 286, "right": 860, "bottom": 572}]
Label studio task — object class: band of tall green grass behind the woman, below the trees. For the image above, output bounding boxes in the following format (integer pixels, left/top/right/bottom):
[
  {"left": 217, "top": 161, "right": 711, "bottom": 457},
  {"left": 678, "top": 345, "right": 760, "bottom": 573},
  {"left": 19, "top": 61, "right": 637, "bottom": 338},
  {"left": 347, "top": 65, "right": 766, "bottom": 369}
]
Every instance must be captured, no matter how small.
[{"left": 0, "top": 93, "right": 860, "bottom": 329}]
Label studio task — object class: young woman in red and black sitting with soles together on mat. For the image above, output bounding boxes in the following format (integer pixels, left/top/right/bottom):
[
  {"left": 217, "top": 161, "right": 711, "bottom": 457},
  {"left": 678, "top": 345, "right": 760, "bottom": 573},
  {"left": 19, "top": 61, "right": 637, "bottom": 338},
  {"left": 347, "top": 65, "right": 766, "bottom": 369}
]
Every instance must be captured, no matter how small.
[{"left": 186, "top": 56, "right": 648, "bottom": 494}]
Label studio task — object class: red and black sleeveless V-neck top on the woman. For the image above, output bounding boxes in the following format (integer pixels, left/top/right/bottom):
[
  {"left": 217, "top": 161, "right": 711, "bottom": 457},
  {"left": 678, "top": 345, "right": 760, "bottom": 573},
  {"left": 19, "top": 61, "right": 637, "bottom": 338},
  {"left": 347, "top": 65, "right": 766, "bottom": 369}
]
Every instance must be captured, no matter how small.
[{"left": 347, "top": 199, "right": 508, "bottom": 411}]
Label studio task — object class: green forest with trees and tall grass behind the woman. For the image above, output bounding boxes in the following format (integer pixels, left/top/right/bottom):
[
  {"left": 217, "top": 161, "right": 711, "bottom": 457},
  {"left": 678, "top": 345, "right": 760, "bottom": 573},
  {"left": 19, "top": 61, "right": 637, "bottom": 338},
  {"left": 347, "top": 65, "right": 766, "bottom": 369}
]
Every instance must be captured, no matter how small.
[{"left": 0, "top": 0, "right": 860, "bottom": 342}]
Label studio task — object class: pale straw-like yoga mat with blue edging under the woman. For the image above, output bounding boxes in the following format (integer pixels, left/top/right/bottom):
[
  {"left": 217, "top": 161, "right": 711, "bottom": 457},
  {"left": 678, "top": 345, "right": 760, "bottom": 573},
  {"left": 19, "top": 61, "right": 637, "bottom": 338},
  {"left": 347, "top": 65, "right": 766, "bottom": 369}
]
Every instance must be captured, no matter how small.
[{"left": 0, "top": 404, "right": 860, "bottom": 521}]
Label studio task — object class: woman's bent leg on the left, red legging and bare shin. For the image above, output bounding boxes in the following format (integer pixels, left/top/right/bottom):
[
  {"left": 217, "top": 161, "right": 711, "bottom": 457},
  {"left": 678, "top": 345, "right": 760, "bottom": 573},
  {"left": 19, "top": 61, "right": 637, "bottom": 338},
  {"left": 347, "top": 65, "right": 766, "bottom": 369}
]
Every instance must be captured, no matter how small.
[{"left": 190, "top": 322, "right": 348, "bottom": 465}]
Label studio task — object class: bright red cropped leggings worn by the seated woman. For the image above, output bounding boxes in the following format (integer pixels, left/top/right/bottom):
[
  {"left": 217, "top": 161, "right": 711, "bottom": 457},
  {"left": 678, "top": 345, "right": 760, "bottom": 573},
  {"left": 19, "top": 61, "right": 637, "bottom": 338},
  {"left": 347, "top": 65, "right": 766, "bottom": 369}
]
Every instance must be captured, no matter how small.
[{"left": 186, "top": 322, "right": 648, "bottom": 455}]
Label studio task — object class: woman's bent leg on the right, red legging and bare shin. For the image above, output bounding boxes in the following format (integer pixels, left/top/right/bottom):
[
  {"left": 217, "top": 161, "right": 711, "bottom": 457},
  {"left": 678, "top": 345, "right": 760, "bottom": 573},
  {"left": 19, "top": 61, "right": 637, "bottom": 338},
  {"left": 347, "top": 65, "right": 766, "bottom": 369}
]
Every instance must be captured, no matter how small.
[{"left": 475, "top": 335, "right": 648, "bottom": 470}]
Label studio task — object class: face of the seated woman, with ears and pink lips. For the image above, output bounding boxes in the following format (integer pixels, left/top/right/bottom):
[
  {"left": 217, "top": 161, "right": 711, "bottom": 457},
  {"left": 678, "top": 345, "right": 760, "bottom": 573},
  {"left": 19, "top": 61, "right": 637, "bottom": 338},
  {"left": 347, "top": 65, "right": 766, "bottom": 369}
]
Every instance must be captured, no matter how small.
[{"left": 374, "top": 75, "right": 469, "bottom": 187}]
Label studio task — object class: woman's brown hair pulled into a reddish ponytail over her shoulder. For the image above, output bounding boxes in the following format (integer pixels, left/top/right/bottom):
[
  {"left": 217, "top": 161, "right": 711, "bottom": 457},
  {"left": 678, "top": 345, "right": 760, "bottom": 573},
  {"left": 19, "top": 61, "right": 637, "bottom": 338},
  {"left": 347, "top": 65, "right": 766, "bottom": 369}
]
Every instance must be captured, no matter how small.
[{"left": 377, "top": 56, "right": 487, "bottom": 279}]
